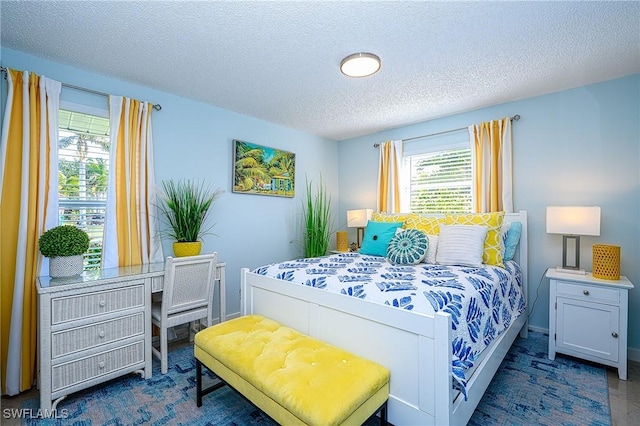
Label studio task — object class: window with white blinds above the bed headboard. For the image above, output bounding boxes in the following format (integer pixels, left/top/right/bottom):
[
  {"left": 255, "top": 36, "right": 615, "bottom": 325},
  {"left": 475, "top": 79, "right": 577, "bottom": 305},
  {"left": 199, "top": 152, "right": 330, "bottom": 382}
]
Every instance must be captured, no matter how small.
[{"left": 402, "top": 129, "right": 472, "bottom": 214}]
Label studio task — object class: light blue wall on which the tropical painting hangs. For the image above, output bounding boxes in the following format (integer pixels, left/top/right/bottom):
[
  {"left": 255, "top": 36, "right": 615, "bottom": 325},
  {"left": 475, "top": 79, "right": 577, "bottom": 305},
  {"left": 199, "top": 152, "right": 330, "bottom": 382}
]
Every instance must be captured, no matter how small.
[{"left": 1, "top": 49, "right": 338, "bottom": 314}]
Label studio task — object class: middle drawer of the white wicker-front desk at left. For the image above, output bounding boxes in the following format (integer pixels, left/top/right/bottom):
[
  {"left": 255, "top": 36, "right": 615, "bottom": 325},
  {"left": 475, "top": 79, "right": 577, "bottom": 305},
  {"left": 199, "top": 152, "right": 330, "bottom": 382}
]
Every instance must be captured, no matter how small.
[{"left": 51, "top": 311, "right": 145, "bottom": 358}]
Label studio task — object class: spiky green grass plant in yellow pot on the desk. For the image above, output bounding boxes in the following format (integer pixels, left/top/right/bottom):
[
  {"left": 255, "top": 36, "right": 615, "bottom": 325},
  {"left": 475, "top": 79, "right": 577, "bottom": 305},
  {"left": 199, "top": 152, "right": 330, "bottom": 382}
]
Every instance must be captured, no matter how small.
[{"left": 159, "top": 179, "right": 222, "bottom": 257}]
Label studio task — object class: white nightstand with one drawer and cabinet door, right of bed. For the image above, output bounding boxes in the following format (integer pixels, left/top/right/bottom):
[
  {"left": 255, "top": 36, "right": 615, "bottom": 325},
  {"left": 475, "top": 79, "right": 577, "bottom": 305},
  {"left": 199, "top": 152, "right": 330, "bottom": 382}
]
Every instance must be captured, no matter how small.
[{"left": 546, "top": 268, "right": 633, "bottom": 380}]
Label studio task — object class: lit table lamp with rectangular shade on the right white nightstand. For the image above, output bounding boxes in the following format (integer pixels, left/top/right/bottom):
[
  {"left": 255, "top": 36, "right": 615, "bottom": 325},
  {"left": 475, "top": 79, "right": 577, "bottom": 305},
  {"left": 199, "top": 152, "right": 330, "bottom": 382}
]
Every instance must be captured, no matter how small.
[{"left": 547, "top": 206, "right": 600, "bottom": 274}]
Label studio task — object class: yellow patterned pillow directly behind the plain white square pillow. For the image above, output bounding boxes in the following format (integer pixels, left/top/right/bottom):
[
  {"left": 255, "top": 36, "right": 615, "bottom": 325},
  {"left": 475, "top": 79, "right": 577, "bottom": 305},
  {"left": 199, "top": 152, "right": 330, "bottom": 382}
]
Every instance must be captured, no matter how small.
[{"left": 444, "top": 212, "right": 504, "bottom": 267}]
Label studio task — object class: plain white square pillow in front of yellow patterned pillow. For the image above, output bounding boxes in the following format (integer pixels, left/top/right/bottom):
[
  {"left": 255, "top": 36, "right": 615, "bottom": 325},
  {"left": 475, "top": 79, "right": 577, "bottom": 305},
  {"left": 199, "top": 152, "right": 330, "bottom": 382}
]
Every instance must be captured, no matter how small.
[{"left": 436, "top": 225, "right": 488, "bottom": 266}]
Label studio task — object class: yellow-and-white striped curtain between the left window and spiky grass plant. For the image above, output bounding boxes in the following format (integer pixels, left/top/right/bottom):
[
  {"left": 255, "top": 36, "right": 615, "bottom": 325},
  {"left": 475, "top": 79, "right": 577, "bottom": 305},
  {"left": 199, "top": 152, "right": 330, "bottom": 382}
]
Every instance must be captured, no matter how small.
[{"left": 103, "top": 96, "right": 164, "bottom": 267}]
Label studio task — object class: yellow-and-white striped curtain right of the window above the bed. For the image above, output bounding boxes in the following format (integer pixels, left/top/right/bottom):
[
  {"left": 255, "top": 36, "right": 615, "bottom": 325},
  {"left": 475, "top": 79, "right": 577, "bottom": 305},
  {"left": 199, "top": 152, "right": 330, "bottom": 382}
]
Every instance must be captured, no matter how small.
[{"left": 469, "top": 117, "right": 513, "bottom": 213}]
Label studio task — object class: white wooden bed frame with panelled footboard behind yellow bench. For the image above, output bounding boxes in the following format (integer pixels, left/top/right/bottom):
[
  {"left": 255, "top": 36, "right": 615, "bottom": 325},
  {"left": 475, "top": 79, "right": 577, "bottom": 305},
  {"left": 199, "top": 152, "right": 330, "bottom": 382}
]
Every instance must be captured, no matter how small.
[{"left": 241, "top": 211, "right": 527, "bottom": 426}]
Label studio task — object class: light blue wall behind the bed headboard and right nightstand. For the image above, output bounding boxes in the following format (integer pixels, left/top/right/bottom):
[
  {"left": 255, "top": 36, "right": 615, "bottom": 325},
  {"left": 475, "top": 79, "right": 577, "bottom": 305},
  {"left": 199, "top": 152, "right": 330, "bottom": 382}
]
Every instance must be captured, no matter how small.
[{"left": 338, "top": 74, "right": 640, "bottom": 352}]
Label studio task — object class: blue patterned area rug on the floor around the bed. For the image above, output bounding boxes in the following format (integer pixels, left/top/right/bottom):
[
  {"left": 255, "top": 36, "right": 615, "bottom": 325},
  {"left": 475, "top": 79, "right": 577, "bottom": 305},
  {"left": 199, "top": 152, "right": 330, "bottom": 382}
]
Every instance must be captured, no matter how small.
[{"left": 22, "top": 332, "right": 610, "bottom": 426}]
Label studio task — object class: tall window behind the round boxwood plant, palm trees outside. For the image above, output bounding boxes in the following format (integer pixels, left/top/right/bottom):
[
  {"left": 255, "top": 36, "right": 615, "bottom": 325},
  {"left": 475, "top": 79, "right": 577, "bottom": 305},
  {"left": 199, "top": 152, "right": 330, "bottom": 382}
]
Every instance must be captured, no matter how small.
[{"left": 58, "top": 105, "right": 110, "bottom": 269}]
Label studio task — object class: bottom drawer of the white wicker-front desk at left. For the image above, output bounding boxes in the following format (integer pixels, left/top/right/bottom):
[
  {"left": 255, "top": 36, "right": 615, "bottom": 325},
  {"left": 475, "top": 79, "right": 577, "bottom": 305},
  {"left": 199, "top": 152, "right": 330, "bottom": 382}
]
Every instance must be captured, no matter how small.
[{"left": 51, "top": 341, "right": 144, "bottom": 392}]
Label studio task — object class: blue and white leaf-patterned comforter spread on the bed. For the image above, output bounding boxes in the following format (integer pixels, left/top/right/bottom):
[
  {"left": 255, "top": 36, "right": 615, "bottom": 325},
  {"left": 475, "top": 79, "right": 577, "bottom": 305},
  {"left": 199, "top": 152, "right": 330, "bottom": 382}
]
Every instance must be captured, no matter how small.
[{"left": 253, "top": 253, "right": 526, "bottom": 399}]
